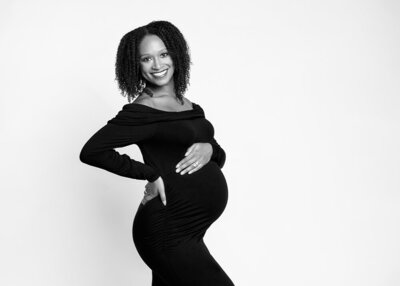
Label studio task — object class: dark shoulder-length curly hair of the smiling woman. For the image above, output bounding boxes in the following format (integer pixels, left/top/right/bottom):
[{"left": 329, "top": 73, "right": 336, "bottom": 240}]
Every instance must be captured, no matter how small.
[{"left": 115, "top": 21, "right": 192, "bottom": 103}]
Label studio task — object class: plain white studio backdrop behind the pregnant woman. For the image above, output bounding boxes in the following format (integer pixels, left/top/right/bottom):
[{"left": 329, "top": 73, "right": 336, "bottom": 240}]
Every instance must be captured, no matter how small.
[{"left": 0, "top": 0, "right": 400, "bottom": 286}]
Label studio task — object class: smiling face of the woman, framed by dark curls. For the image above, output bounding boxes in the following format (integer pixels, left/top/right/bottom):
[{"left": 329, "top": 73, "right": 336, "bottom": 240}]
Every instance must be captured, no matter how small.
[{"left": 139, "top": 35, "right": 174, "bottom": 86}]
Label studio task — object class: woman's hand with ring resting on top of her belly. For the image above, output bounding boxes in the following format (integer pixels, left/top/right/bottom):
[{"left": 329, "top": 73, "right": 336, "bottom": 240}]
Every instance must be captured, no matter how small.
[{"left": 176, "top": 142, "right": 213, "bottom": 175}]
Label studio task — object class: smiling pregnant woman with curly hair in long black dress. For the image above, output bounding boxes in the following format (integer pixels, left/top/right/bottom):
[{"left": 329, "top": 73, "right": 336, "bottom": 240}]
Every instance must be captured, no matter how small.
[{"left": 80, "top": 21, "right": 234, "bottom": 286}]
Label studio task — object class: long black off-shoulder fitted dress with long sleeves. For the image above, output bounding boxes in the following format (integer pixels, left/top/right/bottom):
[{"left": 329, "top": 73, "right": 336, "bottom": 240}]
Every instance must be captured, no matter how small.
[{"left": 80, "top": 103, "right": 234, "bottom": 286}]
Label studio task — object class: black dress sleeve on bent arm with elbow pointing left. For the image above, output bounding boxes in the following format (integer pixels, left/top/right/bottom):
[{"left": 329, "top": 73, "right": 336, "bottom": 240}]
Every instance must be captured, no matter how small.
[{"left": 79, "top": 123, "right": 160, "bottom": 182}]
